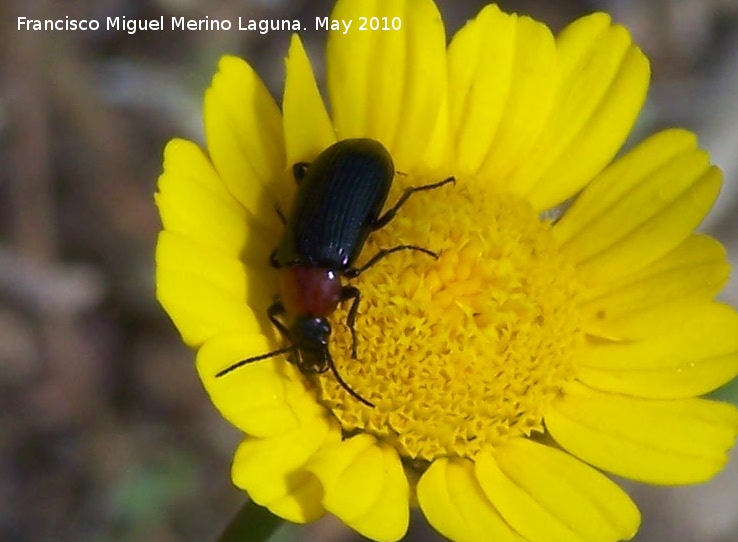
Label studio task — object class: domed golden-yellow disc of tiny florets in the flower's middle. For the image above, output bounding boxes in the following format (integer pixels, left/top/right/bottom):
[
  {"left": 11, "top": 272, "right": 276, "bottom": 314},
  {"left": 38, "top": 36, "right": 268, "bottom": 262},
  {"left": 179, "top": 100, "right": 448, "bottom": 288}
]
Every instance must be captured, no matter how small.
[{"left": 318, "top": 177, "right": 582, "bottom": 460}]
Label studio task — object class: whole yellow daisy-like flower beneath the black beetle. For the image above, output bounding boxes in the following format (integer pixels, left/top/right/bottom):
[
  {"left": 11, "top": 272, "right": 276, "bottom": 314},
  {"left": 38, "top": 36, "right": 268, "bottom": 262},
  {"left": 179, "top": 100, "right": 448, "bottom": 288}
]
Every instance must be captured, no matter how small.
[{"left": 156, "top": 0, "right": 738, "bottom": 542}]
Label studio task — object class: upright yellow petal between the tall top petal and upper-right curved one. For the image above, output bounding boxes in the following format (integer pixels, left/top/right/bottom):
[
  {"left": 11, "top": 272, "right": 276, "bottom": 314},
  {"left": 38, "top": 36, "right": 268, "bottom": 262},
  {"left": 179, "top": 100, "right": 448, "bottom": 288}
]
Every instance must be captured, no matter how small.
[{"left": 448, "top": 5, "right": 558, "bottom": 187}]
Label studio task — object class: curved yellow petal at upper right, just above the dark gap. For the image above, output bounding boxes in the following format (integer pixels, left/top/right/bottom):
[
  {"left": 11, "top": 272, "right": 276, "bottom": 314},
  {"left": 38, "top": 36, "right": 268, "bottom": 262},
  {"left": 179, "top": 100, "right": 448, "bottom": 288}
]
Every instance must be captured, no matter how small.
[{"left": 507, "top": 13, "right": 650, "bottom": 210}]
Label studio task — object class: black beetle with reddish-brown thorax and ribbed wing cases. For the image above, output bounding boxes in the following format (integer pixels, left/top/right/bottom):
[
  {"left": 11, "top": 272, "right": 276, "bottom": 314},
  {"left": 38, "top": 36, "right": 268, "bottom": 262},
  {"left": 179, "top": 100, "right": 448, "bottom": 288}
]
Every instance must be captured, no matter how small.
[{"left": 216, "top": 138, "right": 455, "bottom": 407}]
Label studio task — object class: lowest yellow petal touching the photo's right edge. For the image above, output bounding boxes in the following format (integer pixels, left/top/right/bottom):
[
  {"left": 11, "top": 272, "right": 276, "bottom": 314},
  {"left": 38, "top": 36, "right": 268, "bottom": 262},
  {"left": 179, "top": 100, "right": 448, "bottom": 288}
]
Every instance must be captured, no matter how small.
[{"left": 545, "top": 384, "right": 738, "bottom": 485}]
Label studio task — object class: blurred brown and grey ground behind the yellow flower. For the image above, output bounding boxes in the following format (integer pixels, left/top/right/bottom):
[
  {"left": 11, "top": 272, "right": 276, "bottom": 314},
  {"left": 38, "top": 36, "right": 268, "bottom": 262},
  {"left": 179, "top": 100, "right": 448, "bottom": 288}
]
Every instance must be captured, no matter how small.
[{"left": 0, "top": 0, "right": 738, "bottom": 542}]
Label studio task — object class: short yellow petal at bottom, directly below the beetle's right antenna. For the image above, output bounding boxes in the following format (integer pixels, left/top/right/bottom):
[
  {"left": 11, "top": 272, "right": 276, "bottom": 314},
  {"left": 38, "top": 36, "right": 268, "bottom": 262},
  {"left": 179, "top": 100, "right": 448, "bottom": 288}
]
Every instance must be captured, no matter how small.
[{"left": 306, "top": 434, "right": 410, "bottom": 541}]
